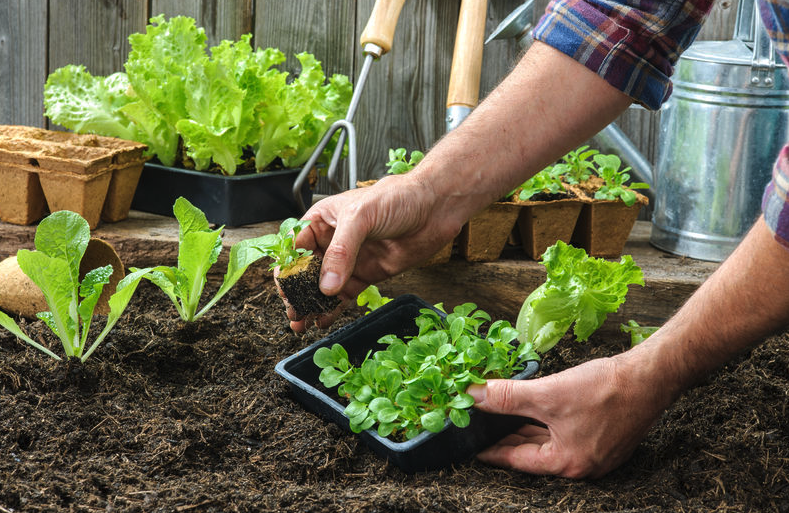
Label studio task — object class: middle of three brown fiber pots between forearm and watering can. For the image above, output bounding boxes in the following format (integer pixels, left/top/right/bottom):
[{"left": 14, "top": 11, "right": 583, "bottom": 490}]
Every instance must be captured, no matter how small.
[{"left": 518, "top": 199, "right": 583, "bottom": 260}]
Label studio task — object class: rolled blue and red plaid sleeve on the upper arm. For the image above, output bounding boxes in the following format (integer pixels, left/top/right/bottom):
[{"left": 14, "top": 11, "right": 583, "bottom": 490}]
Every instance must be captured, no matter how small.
[{"left": 533, "top": 0, "right": 712, "bottom": 109}]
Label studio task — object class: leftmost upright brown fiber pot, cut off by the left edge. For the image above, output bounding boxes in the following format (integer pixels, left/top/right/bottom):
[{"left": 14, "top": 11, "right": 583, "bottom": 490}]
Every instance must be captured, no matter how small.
[{"left": 0, "top": 162, "right": 47, "bottom": 225}]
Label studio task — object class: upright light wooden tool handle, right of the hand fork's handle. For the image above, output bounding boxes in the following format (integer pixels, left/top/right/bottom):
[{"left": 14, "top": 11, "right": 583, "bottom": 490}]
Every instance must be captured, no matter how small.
[{"left": 447, "top": 0, "right": 488, "bottom": 108}]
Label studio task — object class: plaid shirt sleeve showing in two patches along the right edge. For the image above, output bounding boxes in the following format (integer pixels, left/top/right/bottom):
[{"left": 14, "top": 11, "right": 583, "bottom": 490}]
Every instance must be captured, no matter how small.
[{"left": 759, "top": 0, "right": 789, "bottom": 249}]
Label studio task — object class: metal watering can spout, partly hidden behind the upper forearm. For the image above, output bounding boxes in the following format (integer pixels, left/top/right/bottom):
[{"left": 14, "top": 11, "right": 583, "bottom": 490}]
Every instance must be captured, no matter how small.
[{"left": 485, "top": 0, "right": 654, "bottom": 202}]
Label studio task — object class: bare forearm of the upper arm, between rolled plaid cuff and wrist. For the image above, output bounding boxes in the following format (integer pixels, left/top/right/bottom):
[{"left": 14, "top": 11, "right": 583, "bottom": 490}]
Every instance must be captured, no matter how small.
[{"left": 410, "top": 43, "right": 631, "bottom": 229}]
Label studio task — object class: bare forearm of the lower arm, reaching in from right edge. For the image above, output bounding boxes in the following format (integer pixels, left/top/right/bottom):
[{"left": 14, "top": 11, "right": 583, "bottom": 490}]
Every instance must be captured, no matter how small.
[{"left": 622, "top": 217, "right": 789, "bottom": 401}]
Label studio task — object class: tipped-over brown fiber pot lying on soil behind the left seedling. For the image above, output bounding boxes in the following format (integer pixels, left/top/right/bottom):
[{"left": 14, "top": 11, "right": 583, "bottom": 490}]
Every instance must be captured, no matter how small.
[{"left": 0, "top": 239, "right": 125, "bottom": 318}]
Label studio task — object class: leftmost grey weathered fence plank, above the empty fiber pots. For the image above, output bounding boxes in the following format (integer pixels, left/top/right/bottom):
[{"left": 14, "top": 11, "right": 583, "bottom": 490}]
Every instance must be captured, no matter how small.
[{"left": 0, "top": 0, "right": 47, "bottom": 127}]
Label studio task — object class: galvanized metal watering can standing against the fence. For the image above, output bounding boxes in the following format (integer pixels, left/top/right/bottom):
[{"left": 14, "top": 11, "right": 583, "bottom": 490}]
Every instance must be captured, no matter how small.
[{"left": 488, "top": 0, "right": 789, "bottom": 262}]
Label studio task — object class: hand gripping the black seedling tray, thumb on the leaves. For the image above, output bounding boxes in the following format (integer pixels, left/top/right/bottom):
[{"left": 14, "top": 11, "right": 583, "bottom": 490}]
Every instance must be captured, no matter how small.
[{"left": 467, "top": 355, "right": 673, "bottom": 478}]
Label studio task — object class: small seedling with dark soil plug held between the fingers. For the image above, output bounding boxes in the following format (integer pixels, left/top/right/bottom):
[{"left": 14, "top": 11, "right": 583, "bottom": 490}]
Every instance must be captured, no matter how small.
[{"left": 257, "top": 218, "right": 340, "bottom": 317}]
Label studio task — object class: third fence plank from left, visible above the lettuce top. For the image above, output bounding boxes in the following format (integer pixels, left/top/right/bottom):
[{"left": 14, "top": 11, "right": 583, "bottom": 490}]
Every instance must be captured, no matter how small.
[{"left": 150, "top": 0, "right": 254, "bottom": 47}]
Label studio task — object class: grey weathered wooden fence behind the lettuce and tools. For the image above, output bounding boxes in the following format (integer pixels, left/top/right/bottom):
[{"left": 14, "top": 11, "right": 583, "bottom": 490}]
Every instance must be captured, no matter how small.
[{"left": 0, "top": 0, "right": 736, "bottom": 186}]
